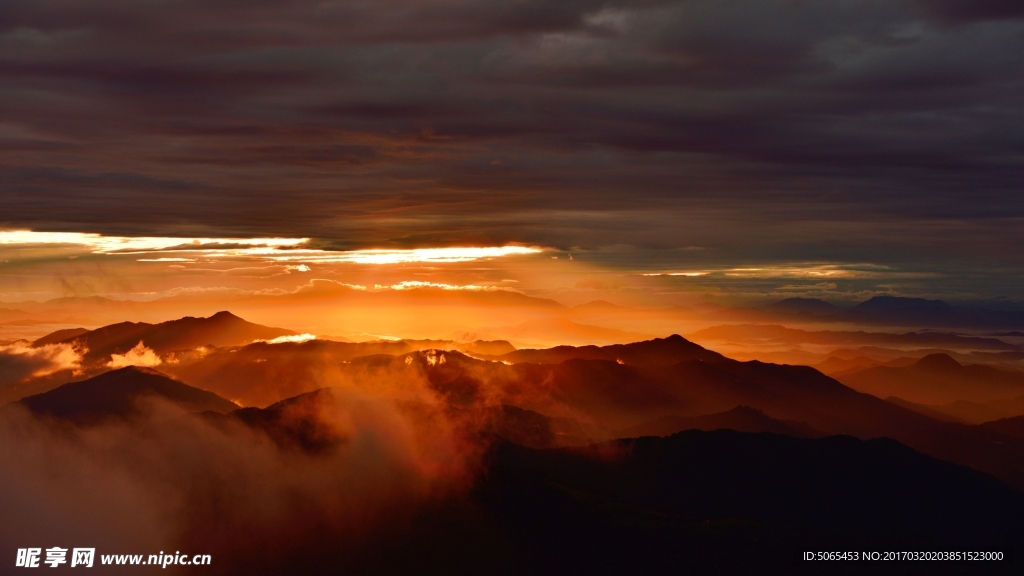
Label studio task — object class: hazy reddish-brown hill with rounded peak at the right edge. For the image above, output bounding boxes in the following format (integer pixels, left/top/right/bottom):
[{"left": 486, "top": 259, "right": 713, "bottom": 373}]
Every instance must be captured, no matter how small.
[{"left": 840, "top": 354, "right": 1024, "bottom": 405}]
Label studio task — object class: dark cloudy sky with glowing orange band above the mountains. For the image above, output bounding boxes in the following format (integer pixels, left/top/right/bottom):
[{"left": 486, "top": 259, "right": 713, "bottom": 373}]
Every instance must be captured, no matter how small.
[{"left": 0, "top": 0, "right": 1024, "bottom": 304}]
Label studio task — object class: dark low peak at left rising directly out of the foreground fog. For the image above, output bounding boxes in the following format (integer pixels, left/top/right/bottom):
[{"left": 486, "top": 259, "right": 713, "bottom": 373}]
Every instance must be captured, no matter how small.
[{"left": 17, "top": 366, "right": 238, "bottom": 424}]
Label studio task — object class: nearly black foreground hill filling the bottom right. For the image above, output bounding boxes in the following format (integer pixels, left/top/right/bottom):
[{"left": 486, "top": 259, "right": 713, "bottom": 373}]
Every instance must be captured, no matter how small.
[{"left": 477, "top": 430, "right": 1024, "bottom": 575}]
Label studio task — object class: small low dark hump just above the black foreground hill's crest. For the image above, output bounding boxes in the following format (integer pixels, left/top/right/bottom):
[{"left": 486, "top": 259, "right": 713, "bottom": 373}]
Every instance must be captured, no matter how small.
[{"left": 614, "top": 406, "right": 824, "bottom": 436}]
